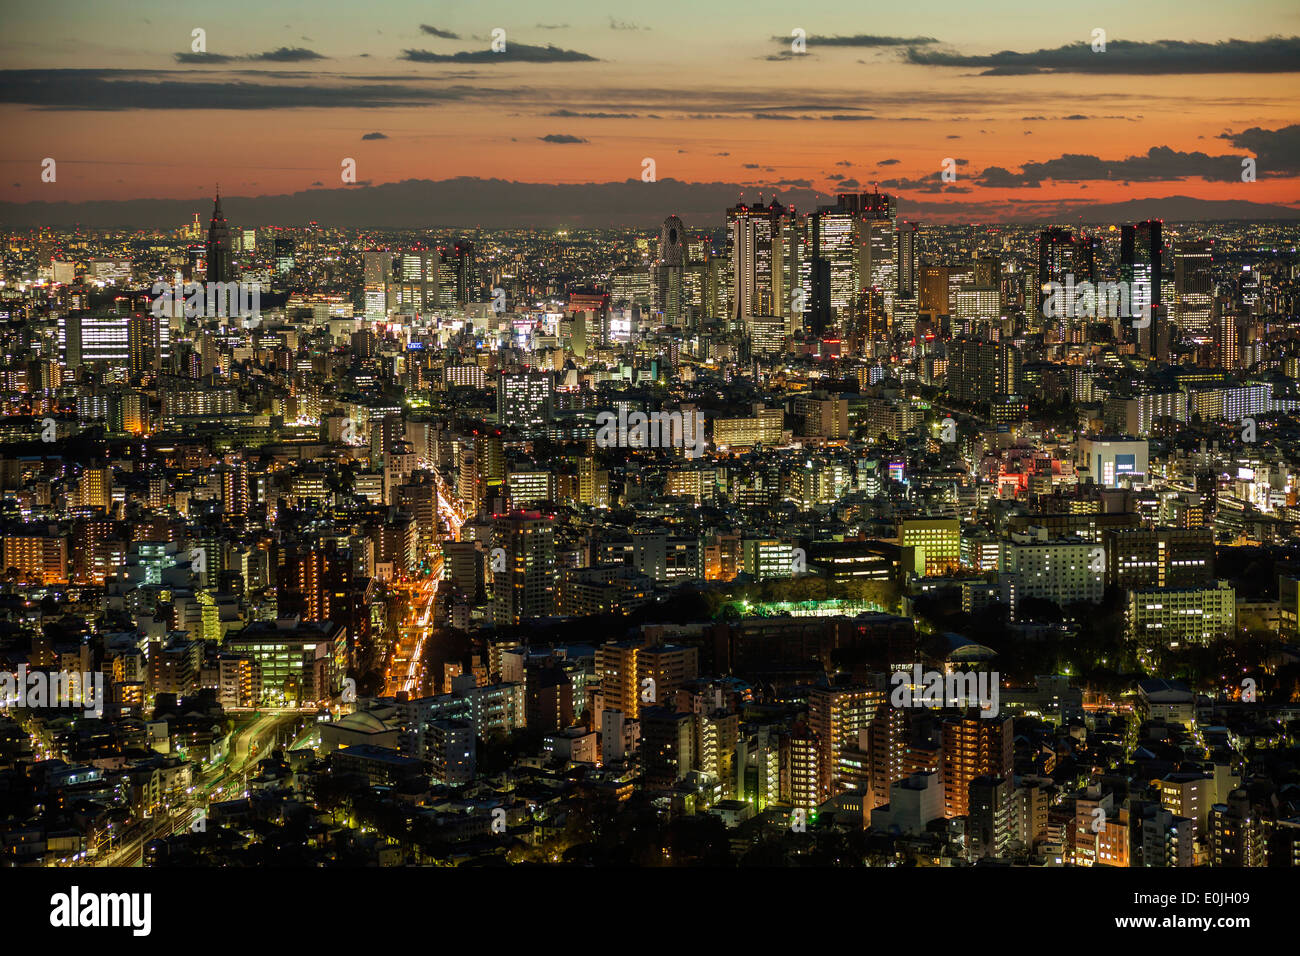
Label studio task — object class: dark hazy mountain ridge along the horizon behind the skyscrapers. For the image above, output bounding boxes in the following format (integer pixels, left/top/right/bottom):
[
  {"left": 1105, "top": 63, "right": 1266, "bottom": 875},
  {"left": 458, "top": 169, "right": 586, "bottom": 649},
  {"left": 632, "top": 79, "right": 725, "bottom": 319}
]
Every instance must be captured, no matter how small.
[{"left": 0, "top": 177, "right": 1300, "bottom": 229}]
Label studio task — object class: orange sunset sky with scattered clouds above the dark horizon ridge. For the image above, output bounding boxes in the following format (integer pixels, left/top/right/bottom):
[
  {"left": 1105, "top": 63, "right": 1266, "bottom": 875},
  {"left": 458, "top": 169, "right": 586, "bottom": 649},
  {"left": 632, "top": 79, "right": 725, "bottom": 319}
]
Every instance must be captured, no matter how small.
[{"left": 0, "top": 0, "right": 1300, "bottom": 221}]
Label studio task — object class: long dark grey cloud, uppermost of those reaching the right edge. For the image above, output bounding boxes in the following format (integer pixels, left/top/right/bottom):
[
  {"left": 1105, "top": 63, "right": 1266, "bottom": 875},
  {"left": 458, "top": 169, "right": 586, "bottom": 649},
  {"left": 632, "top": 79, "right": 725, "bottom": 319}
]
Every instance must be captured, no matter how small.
[{"left": 907, "top": 36, "right": 1300, "bottom": 77}]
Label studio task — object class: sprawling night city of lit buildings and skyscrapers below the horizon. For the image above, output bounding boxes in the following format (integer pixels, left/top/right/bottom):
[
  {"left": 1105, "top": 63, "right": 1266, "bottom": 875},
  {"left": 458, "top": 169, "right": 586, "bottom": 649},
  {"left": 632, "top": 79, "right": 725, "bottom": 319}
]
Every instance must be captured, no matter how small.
[{"left": 0, "top": 193, "right": 1300, "bottom": 866}]
